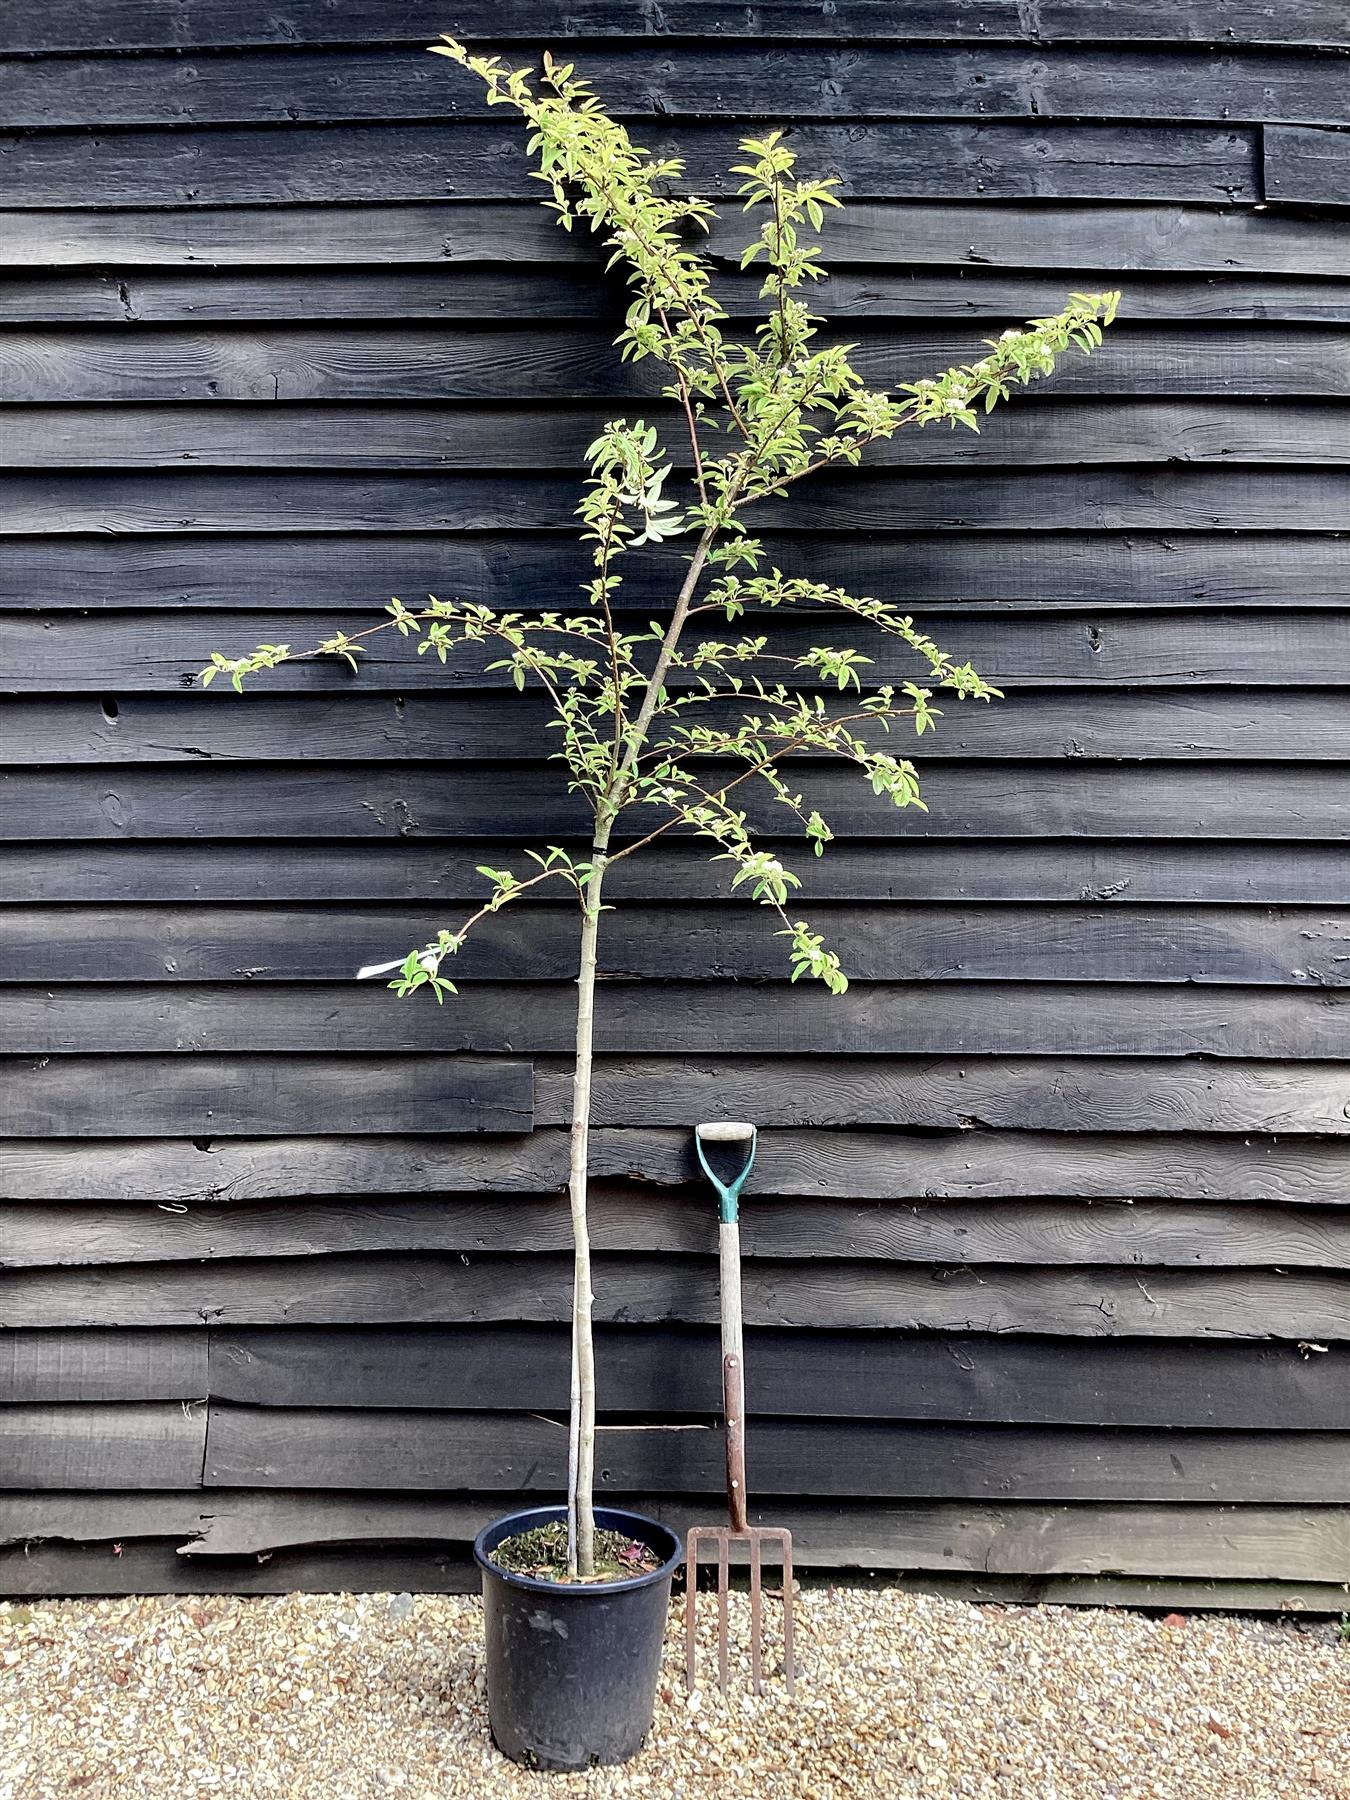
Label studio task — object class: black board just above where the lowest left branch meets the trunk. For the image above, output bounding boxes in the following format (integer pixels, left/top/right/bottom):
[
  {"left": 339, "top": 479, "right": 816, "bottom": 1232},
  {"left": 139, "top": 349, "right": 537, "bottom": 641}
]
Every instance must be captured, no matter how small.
[{"left": 0, "top": 766, "right": 1350, "bottom": 842}]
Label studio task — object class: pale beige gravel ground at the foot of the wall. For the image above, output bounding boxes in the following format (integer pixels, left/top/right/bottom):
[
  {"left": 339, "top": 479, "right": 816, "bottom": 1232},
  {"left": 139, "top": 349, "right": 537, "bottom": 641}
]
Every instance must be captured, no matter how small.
[{"left": 0, "top": 1589, "right": 1350, "bottom": 1800}]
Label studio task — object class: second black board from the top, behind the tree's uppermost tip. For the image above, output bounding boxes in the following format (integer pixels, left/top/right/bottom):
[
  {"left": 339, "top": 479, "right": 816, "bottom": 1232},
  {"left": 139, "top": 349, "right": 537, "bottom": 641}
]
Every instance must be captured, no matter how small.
[{"left": 0, "top": 45, "right": 1350, "bottom": 130}]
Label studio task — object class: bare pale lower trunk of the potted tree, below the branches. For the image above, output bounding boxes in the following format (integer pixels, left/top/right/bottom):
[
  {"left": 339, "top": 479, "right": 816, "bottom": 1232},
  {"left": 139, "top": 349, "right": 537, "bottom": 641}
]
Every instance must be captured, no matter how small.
[{"left": 567, "top": 832, "right": 608, "bottom": 1575}]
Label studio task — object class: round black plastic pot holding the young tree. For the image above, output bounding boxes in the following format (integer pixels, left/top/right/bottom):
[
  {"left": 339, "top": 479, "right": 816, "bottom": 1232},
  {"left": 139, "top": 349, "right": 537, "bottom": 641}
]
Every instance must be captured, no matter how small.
[{"left": 473, "top": 1507, "right": 682, "bottom": 1769}]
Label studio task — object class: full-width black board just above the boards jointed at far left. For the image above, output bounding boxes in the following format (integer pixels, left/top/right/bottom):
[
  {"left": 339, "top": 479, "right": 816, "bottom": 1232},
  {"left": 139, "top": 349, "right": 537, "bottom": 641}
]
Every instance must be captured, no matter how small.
[{"left": 0, "top": 1253, "right": 1350, "bottom": 1339}]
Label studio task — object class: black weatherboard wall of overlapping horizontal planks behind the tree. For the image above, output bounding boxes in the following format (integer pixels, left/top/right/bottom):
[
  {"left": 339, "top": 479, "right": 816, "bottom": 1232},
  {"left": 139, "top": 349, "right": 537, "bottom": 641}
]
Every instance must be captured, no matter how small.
[{"left": 0, "top": 0, "right": 1350, "bottom": 1606}]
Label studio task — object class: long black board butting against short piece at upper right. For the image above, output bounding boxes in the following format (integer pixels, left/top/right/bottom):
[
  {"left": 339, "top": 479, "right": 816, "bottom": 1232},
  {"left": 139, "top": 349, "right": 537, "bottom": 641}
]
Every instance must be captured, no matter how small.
[{"left": 0, "top": 121, "right": 1260, "bottom": 207}]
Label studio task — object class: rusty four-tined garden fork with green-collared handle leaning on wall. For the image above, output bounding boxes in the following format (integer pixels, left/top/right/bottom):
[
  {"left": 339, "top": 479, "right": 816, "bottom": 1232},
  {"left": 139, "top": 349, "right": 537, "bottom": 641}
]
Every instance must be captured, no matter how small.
[{"left": 684, "top": 1121, "right": 796, "bottom": 1694}]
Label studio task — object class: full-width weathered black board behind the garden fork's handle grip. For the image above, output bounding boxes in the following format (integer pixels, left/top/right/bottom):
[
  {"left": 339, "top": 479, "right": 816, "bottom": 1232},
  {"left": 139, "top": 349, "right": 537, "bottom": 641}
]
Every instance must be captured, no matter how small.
[{"left": 0, "top": 1125, "right": 1350, "bottom": 1206}]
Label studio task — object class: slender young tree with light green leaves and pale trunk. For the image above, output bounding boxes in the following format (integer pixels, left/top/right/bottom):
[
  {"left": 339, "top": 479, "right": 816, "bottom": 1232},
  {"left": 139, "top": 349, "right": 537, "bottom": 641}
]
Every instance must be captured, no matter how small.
[{"left": 202, "top": 38, "right": 1120, "bottom": 1575}]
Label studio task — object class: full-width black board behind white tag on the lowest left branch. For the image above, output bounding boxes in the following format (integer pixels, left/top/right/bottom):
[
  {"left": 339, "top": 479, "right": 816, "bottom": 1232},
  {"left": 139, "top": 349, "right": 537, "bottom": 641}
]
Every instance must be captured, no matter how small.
[{"left": 0, "top": 907, "right": 1350, "bottom": 993}]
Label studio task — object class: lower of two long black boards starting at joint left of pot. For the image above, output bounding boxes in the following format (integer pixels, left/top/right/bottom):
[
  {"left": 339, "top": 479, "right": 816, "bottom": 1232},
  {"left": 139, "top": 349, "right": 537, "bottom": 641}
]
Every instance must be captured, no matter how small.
[{"left": 205, "top": 1406, "right": 1345, "bottom": 1505}]
